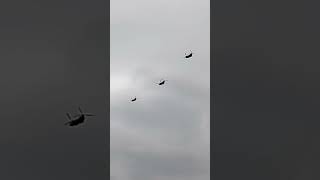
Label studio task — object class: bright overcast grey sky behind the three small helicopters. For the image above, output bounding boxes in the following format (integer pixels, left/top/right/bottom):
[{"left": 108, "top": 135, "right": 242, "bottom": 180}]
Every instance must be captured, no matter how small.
[{"left": 110, "top": 0, "right": 210, "bottom": 180}]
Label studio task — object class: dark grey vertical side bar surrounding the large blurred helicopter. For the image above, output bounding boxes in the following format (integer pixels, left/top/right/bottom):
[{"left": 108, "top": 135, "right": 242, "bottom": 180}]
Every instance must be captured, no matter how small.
[{"left": 0, "top": 0, "right": 110, "bottom": 180}]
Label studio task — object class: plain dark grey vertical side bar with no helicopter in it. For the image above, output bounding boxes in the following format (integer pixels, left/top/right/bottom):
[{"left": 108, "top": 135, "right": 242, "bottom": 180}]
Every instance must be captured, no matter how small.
[{"left": 211, "top": 0, "right": 320, "bottom": 180}]
